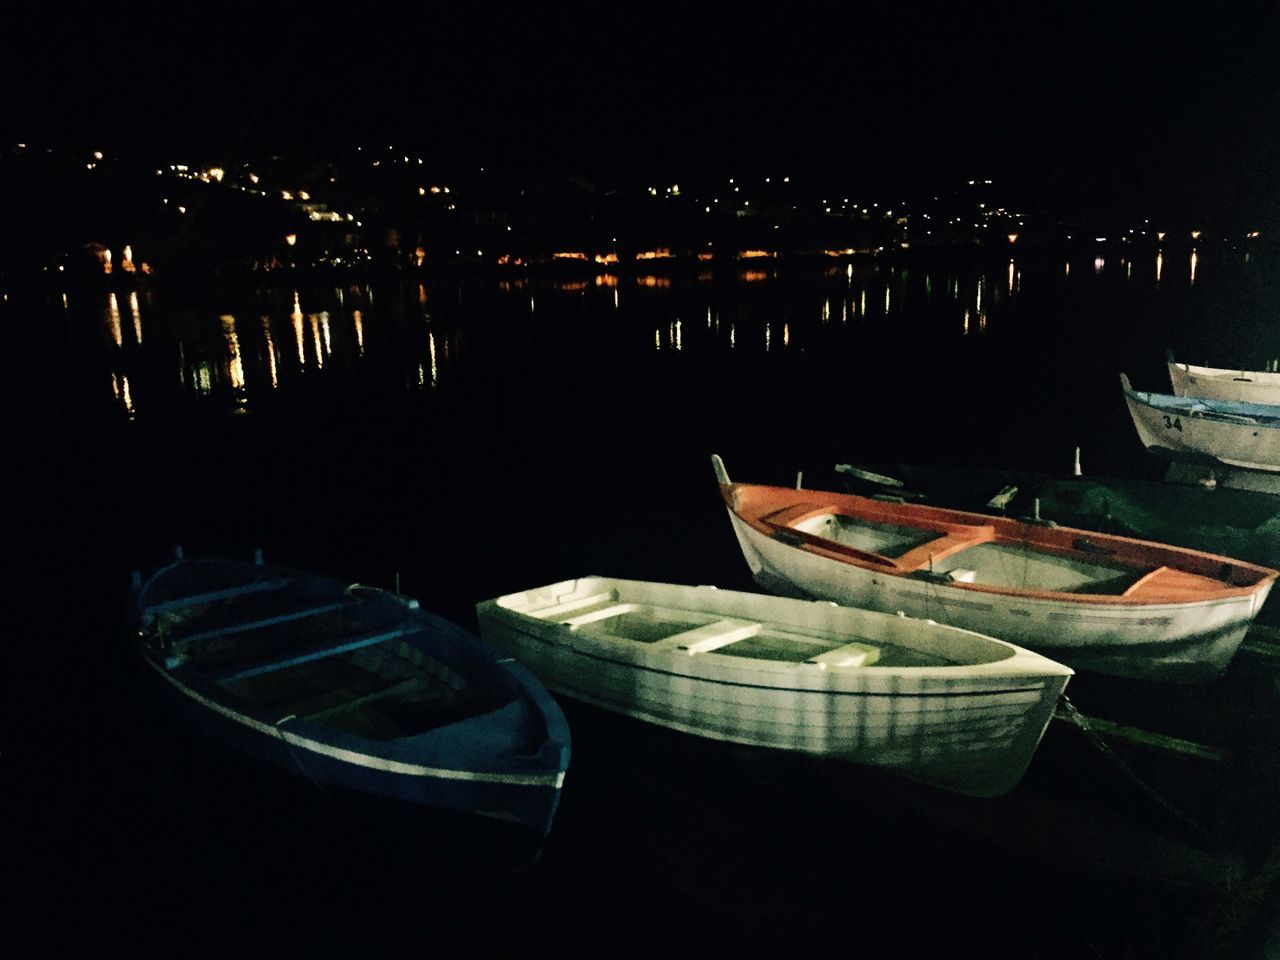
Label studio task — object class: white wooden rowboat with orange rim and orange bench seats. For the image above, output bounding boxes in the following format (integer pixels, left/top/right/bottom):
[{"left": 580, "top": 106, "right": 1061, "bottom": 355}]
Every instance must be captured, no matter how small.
[{"left": 712, "top": 456, "right": 1280, "bottom": 682}]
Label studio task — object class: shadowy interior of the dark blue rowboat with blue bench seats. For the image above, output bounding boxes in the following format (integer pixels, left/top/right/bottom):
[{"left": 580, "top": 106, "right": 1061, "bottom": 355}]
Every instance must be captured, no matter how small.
[{"left": 152, "top": 579, "right": 513, "bottom": 740}]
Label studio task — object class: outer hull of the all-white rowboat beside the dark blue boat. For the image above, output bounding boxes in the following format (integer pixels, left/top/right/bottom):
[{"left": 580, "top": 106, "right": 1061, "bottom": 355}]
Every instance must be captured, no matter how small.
[{"left": 477, "top": 585, "right": 1070, "bottom": 796}]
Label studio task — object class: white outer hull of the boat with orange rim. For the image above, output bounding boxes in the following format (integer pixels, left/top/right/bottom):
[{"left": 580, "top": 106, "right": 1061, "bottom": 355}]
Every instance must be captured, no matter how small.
[{"left": 728, "top": 509, "right": 1271, "bottom": 682}]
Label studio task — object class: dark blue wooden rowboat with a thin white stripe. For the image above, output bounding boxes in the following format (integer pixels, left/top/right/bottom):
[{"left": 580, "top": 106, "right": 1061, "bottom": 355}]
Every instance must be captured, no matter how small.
[{"left": 134, "top": 552, "right": 570, "bottom": 836}]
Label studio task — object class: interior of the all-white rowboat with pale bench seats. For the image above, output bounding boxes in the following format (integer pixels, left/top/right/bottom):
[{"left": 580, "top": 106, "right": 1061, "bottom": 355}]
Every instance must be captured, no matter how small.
[{"left": 503, "top": 589, "right": 962, "bottom": 667}]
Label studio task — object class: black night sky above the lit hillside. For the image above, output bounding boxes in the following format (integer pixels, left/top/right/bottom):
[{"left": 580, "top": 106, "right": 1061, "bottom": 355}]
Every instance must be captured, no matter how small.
[{"left": 0, "top": 3, "right": 1280, "bottom": 211}]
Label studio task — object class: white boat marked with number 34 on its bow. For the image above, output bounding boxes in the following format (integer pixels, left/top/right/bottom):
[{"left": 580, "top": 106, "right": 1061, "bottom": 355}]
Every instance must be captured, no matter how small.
[{"left": 1120, "top": 374, "right": 1280, "bottom": 472}]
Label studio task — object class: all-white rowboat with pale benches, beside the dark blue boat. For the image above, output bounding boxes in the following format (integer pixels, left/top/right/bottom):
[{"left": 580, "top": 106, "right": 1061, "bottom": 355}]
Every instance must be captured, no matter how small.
[{"left": 476, "top": 577, "right": 1071, "bottom": 796}]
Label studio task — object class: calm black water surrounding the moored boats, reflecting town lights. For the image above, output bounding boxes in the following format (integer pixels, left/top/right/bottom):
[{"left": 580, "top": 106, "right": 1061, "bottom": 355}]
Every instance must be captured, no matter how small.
[{"left": 12, "top": 246, "right": 1280, "bottom": 957}]
